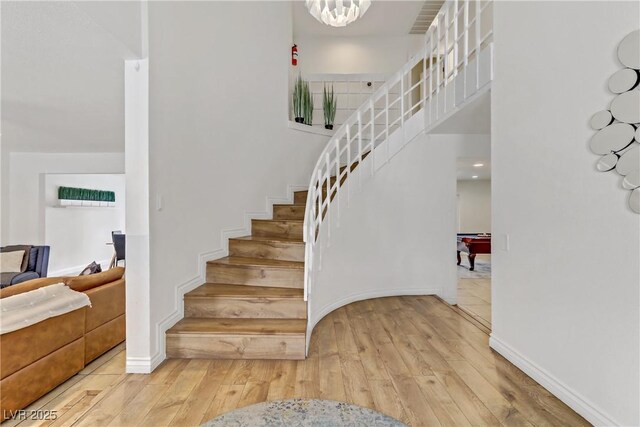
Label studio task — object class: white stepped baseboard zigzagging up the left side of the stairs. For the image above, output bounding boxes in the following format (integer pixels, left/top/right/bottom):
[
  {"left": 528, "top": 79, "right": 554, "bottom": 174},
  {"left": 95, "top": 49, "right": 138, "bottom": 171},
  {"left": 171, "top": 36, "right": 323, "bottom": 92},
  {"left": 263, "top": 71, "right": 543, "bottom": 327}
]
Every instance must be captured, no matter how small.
[{"left": 138, "top": 185, "right": 308, "bottom": 374}]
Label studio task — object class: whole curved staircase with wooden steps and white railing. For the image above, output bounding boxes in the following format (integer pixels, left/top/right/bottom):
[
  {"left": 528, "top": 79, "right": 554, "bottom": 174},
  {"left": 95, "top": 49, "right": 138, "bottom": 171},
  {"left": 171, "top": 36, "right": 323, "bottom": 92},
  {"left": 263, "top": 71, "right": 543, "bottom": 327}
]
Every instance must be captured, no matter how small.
[{"left": 166, "top": 0, "right": 493, "bottom": 359}]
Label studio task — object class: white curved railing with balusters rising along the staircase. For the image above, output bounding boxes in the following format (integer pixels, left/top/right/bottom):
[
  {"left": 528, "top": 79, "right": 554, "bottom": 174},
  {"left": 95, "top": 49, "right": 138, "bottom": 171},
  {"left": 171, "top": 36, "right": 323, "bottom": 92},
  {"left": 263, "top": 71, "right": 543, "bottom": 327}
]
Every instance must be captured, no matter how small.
[{"left": 304, "top": 0, "right": 493, "bottom": 299}]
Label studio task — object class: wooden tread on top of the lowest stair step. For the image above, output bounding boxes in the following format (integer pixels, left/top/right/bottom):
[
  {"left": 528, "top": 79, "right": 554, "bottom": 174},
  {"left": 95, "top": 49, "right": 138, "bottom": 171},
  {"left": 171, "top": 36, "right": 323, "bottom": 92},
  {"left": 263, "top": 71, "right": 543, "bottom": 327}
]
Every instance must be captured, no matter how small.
[{"left": 167, "top": 317, "right": 307, "bottom": 336}]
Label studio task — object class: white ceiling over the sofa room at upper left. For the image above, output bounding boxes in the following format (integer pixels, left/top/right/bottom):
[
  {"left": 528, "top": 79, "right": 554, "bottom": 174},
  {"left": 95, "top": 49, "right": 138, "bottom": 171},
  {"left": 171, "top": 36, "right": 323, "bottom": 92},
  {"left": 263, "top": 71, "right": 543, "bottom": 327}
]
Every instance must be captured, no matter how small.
[{"left": 0, "top": 1, "right": 140, "bottom": 152}]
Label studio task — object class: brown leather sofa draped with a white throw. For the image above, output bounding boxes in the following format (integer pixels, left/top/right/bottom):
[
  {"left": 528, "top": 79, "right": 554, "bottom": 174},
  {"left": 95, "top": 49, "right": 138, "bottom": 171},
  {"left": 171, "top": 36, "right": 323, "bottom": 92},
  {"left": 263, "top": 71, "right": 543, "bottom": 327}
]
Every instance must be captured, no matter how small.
[{"left": 0, "top": 267, "right": 125, "bottom": 421}]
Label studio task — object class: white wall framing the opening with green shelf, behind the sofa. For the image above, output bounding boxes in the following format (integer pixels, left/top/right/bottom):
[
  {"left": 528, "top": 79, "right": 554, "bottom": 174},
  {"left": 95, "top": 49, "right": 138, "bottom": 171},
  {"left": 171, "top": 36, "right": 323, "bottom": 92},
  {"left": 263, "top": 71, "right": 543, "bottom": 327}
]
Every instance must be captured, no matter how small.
[{"left": 2, "top": 153, "right": 124, "bottom": 245}]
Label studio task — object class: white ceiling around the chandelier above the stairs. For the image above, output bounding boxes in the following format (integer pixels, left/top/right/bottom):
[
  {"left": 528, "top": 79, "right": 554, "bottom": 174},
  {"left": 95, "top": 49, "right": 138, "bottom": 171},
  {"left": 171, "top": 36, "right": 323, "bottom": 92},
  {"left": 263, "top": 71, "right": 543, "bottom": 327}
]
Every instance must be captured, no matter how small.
[{"left": 293, "top": 0, "right": 424, "bottom": 37}]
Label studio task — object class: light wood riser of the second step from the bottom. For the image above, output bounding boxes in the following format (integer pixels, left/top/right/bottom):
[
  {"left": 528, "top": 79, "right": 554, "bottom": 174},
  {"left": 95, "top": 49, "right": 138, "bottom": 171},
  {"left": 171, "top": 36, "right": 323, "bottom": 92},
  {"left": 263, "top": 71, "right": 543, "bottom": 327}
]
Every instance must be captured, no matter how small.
[{"left": 184, "top": 297, "right": 307, "bottom": 319}]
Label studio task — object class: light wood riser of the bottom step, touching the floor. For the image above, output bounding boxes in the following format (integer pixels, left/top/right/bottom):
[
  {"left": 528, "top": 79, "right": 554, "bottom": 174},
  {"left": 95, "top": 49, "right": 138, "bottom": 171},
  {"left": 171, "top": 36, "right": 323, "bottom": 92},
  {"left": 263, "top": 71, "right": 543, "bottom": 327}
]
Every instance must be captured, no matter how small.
[{"left": 167, "top": 334, "right": 305, "bottom": 360}]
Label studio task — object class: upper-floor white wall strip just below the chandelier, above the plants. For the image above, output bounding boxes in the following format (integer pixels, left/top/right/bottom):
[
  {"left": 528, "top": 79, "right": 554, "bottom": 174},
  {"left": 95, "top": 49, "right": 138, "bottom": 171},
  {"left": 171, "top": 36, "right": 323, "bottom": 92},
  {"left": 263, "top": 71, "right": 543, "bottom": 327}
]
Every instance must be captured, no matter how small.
[{"left": 294, "top": 35, "right": 424, "bottom": 76}]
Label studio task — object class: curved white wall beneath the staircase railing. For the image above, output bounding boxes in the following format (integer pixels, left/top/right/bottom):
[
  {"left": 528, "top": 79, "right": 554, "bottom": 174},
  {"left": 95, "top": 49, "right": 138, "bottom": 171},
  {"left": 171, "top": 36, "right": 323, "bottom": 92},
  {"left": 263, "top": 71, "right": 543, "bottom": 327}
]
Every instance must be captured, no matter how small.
[{"left": 309, "top": 134, "right": 456, "bottom": 336}]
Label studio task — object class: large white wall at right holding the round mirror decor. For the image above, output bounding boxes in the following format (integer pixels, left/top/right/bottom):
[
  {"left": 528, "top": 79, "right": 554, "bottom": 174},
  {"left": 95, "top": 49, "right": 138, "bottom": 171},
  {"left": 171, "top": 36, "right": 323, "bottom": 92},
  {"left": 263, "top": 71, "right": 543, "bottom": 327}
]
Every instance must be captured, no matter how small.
[{"left": 491, "top": 1, "right": 640, "bottom": 426}]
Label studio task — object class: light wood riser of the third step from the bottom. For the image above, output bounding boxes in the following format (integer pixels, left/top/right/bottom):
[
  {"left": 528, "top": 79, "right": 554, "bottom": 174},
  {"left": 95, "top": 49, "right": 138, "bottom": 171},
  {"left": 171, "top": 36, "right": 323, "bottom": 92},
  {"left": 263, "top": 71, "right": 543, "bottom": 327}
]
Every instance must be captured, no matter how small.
[{"left": 207, "top": 264, "right": 304, "bottom": 289}]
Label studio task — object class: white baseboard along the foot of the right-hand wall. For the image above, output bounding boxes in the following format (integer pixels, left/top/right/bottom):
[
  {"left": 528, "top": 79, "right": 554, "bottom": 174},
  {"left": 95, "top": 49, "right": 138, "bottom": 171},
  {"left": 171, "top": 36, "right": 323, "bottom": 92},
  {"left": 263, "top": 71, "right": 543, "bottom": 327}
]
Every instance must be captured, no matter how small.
[{"left": 489, "top": 333, "right": 622, "bottom": 426}]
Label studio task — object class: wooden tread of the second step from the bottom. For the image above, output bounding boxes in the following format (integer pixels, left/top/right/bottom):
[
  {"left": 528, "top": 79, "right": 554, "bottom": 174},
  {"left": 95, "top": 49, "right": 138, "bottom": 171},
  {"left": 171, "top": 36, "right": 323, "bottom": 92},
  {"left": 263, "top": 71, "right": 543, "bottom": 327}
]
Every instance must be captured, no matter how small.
[{"left": 185, "top": 283, "right": 304, "bottom": 299}]
